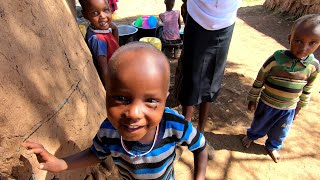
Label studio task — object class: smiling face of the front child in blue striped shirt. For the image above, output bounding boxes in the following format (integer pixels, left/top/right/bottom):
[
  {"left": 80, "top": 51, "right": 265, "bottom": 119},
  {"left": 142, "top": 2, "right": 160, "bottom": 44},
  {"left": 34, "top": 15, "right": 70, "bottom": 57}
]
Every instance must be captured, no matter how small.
[{"left": 106, "top": 50, "right": 168, "bottom": 143}]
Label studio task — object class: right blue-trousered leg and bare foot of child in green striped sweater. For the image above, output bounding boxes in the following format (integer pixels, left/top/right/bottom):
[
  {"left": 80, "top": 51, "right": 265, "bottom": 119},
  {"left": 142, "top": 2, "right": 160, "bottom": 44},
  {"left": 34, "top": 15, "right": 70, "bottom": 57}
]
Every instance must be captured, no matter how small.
[{"left": 266, "top": 109, "right": 295, "bottom": 162}]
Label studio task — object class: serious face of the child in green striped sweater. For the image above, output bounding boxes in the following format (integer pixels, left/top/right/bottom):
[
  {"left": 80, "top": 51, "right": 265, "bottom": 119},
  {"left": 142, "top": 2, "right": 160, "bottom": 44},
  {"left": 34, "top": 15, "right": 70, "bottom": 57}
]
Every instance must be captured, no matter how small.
[{"left": 289, "top": 25, "right": 320, "bottom": 59}]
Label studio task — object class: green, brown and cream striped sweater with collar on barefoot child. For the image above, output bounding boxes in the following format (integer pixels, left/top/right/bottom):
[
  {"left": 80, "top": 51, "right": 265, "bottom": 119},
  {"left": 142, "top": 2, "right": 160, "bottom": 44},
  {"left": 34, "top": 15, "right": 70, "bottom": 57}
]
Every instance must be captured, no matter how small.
[{"left": 248, "top": 50, "right": 319, "bottom": 110}]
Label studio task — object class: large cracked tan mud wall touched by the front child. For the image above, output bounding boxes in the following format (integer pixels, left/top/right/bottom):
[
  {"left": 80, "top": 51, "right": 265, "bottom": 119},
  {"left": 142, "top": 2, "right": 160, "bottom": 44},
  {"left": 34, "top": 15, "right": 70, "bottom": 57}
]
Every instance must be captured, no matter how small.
[{"left": 0, "top": 0, "right": 106, "bottom": 179}]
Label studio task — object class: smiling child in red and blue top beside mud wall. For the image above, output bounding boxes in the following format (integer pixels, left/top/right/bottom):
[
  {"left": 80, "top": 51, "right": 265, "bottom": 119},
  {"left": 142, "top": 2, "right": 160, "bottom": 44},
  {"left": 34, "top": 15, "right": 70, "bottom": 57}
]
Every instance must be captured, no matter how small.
[{"left": 79, "top": 0, "right": 119, "bottom": 87}]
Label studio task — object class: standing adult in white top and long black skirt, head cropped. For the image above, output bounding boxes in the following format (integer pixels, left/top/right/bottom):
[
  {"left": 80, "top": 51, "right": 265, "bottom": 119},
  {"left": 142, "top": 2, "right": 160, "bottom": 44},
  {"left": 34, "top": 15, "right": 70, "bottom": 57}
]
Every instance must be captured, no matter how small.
[{"left": 178, "top": 0, "right": 241, "bottom": 132}]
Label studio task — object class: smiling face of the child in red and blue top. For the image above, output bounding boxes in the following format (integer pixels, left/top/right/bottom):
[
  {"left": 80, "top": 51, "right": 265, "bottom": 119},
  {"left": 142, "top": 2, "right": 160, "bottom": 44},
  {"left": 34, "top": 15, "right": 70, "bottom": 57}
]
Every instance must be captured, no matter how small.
[{"left": 83, "top": 0, "right": 112, "bottom": 30}]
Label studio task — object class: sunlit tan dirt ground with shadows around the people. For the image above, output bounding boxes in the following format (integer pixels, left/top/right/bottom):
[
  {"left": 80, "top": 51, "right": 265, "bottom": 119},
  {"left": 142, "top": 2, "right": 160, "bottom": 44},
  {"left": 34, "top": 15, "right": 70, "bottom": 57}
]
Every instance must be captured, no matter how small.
[{"left": 115, "top": 0, "right": 320, "bottom": 180}]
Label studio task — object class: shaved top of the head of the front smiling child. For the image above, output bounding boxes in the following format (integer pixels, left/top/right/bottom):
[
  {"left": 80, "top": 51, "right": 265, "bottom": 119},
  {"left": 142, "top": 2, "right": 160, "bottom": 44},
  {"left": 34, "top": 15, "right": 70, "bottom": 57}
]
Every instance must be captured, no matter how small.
[{"left": 106, "top": 42, "right": 170, "bottom": 91}]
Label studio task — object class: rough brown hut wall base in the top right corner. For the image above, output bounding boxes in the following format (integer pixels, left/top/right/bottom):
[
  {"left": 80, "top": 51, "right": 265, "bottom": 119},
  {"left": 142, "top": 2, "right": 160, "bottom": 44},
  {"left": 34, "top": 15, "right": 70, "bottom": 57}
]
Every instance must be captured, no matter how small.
[{"left": 264, "top": 0, "right": 320, "bottom": 17}]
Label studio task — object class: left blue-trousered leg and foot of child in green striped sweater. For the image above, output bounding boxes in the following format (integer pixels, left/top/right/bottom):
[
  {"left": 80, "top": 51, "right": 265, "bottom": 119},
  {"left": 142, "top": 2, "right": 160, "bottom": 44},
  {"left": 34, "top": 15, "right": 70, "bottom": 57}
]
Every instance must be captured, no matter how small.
[{"left": 242, "top": 101, "right": 276, "bottom": 148}]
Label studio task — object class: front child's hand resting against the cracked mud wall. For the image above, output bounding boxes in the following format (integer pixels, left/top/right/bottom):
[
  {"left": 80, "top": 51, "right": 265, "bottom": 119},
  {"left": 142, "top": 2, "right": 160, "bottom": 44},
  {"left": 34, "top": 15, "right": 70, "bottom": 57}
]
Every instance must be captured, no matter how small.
[{"left": 21, "top": 141, "right": 68, "bottom": 172}]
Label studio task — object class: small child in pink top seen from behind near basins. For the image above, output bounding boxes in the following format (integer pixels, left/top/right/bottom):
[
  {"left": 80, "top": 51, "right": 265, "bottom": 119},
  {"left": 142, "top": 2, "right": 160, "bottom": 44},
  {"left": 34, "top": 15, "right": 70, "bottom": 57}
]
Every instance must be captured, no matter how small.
[{"left": 159, "top": 0, "right": 181, "bottom": 44}]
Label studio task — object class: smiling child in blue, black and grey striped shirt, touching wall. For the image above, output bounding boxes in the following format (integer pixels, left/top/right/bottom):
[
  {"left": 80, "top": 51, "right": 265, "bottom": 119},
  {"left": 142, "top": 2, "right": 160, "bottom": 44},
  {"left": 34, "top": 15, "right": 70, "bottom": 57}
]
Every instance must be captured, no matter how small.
[{"left": 22, "top": 42, "right": 208, "bottom": 180}]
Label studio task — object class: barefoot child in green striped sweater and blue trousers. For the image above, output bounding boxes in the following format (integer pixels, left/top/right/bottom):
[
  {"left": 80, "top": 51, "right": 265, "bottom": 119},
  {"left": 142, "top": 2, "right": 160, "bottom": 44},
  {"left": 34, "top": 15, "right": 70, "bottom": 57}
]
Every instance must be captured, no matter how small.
[{"left": 242, "top": 14, "right": 320, "bottom": 162}]
